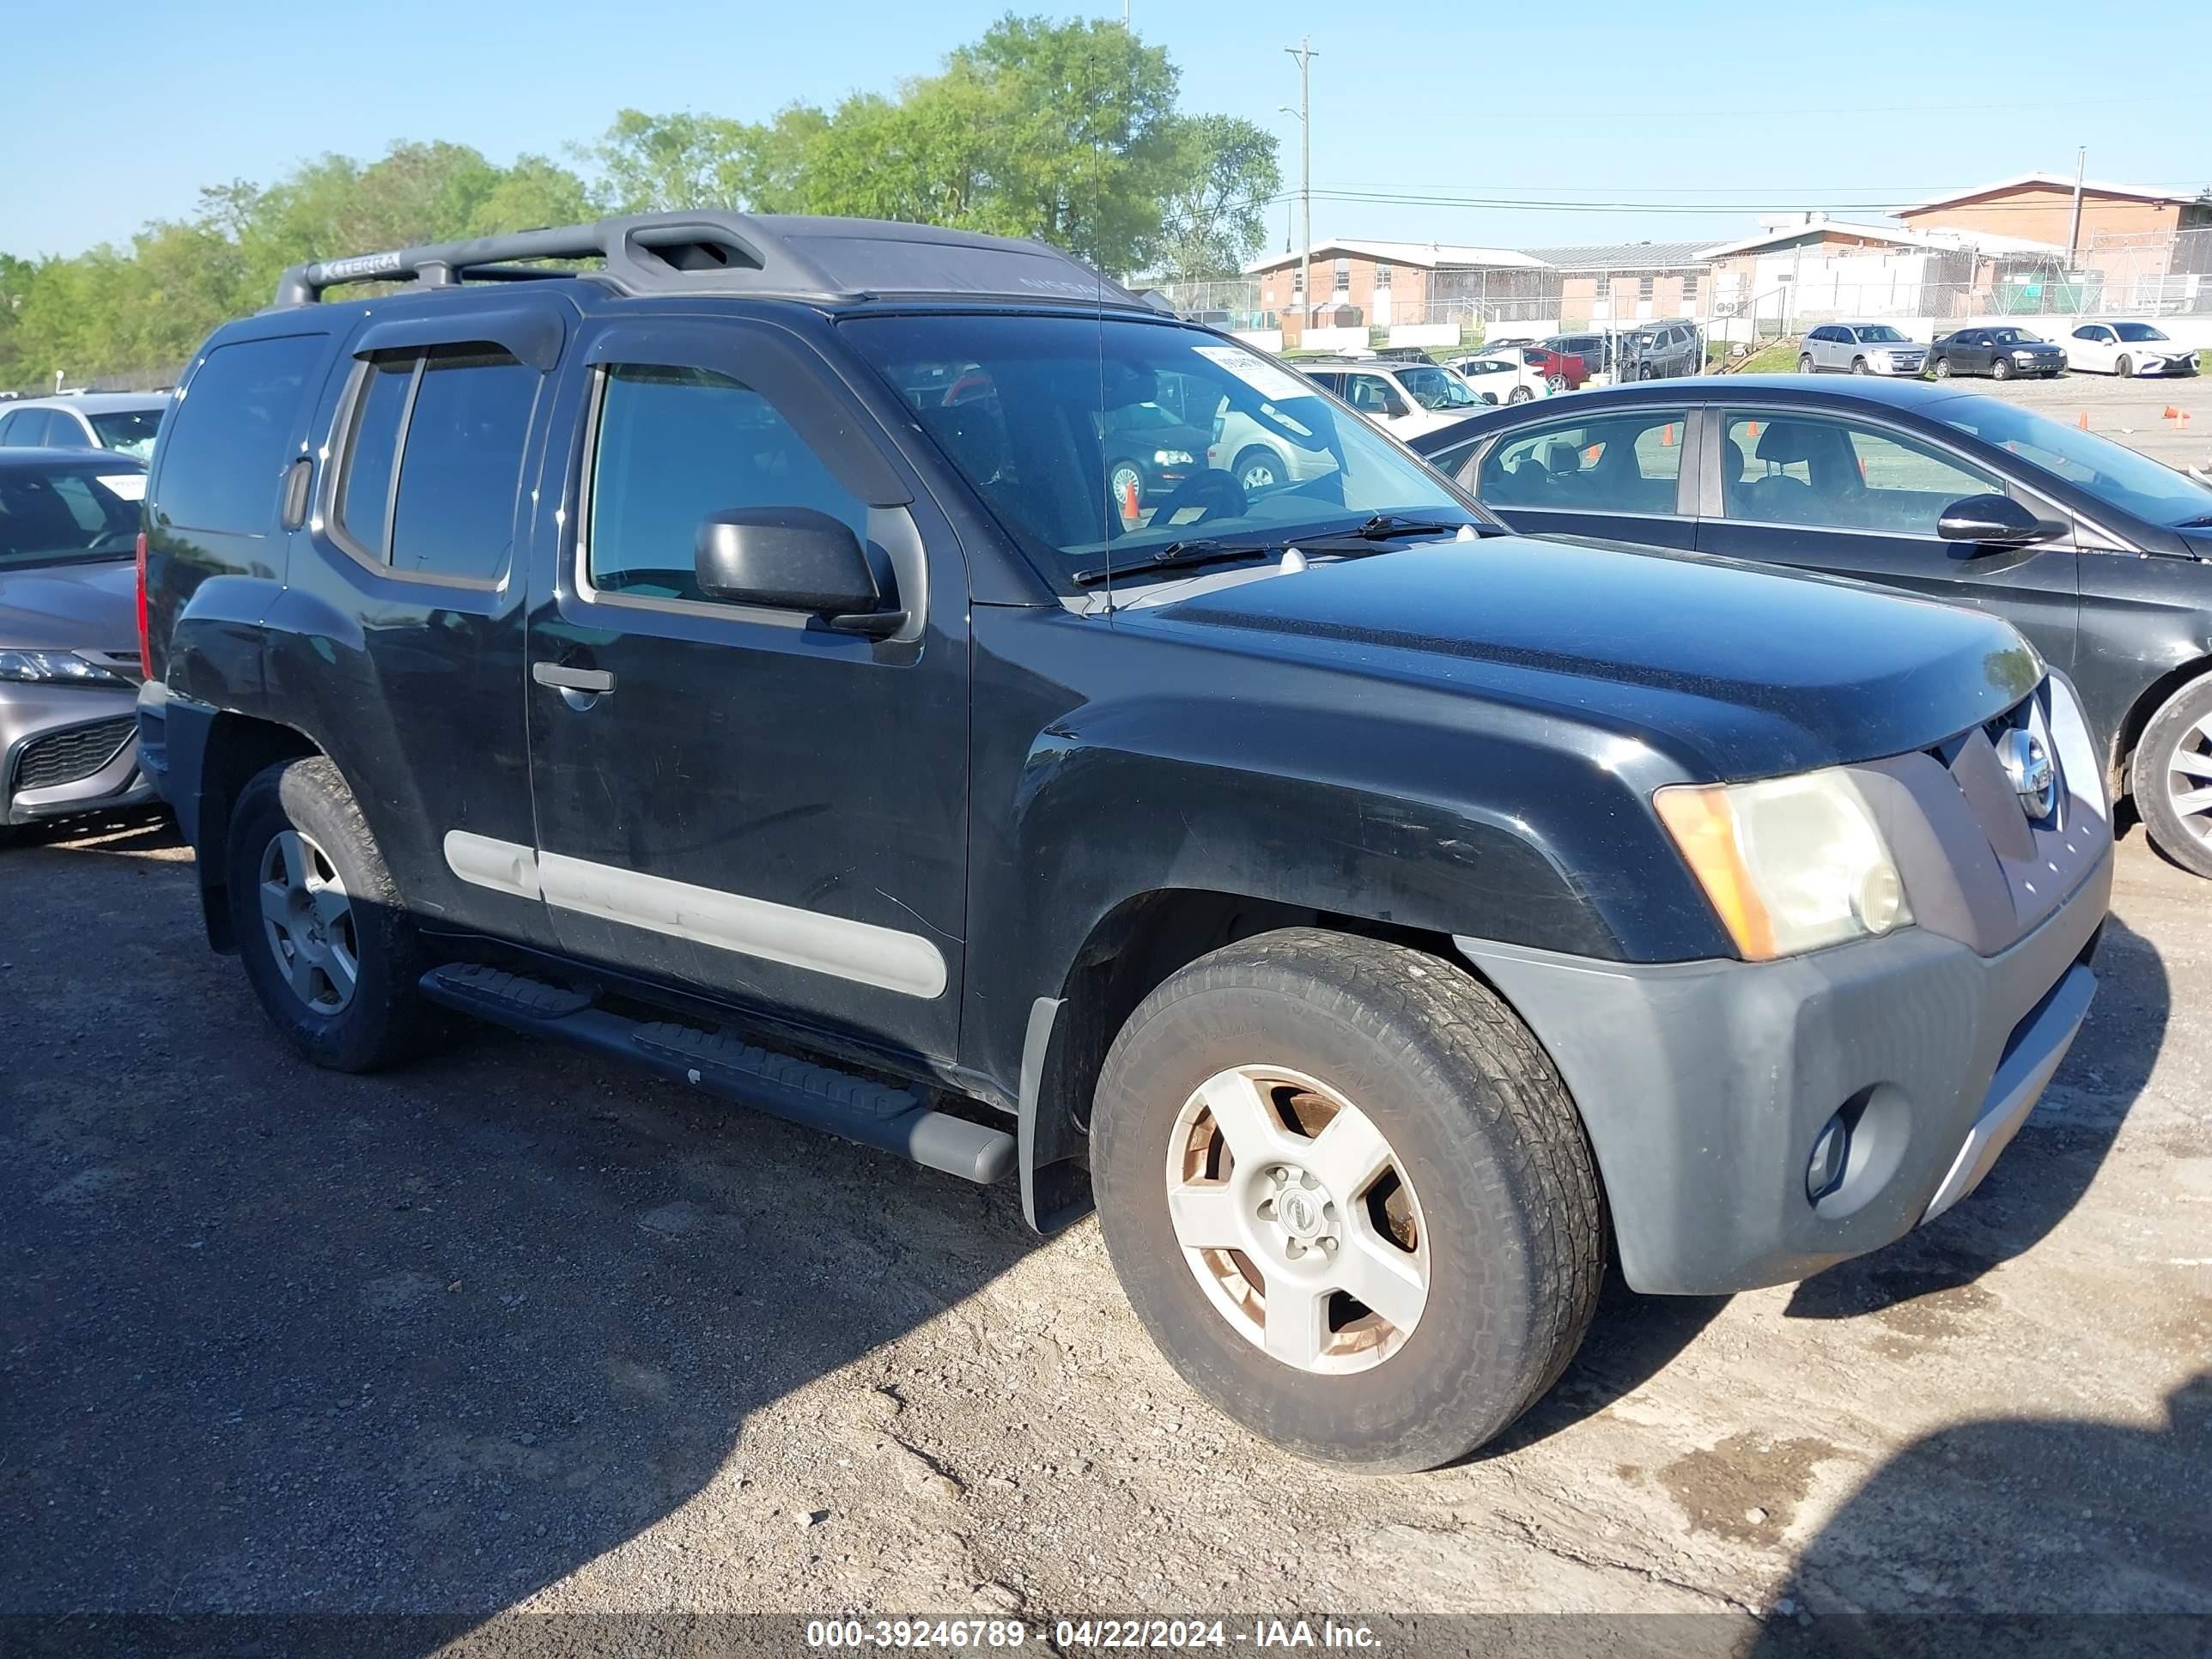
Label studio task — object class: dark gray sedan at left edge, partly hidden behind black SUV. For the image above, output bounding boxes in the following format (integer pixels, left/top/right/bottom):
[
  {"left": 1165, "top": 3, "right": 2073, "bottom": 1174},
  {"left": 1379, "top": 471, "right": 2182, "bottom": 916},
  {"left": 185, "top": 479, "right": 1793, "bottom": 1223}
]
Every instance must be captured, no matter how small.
[{"left": 0, "top": 449, "right": 155, "bottom": 834}]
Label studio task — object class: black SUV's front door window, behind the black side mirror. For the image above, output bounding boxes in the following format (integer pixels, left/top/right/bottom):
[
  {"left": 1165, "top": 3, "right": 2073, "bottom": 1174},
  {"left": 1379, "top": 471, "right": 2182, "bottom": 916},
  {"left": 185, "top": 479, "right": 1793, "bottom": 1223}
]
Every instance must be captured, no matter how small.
[{"left": 584, "top": 362, "right": 867, "bottom": 602}]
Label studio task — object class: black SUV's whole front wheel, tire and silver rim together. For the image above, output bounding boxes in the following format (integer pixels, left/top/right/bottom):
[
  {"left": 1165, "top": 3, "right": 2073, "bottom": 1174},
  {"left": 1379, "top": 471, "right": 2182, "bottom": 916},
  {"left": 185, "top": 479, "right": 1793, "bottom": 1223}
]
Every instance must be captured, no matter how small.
[{"left": 1091, "top": 929, "right": 1604, "bottom": 1471}]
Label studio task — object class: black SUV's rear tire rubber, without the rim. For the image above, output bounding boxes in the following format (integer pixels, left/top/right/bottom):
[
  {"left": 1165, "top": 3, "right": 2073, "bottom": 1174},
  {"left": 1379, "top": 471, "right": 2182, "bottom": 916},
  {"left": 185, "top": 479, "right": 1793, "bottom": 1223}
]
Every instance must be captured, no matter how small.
[{"left": 223, "top": 754, "right": 447, "bottom": 1071}]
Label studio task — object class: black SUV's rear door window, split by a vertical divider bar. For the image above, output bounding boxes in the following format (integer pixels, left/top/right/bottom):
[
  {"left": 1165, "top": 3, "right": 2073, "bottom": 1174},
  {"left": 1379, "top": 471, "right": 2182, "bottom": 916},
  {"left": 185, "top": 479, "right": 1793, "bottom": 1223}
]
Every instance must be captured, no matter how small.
[{"left": 337, "top": 345, "right": 542, "bottom": 586}]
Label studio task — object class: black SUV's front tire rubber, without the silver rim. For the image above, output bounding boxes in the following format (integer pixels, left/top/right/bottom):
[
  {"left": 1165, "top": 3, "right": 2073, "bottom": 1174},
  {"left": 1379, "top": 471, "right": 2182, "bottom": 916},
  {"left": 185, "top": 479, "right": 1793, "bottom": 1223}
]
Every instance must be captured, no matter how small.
[{"left": 1091, "top": 929, "right": 1606, "bottom": 1471}]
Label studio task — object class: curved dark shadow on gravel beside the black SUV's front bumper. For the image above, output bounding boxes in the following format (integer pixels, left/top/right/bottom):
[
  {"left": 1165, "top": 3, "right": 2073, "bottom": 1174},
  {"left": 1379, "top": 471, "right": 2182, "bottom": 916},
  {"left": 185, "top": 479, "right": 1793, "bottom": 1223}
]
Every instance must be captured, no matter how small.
[{"left": 1787, "top": 915, "right": 2172, "bottom": 1318}]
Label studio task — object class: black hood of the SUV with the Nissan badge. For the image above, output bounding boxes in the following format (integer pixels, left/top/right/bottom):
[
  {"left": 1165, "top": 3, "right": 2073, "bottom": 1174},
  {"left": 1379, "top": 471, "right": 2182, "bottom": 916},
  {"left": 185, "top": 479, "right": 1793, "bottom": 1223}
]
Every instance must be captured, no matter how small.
[{"left": 1121, "top": 538, "right": 2044, "bottom": 781}]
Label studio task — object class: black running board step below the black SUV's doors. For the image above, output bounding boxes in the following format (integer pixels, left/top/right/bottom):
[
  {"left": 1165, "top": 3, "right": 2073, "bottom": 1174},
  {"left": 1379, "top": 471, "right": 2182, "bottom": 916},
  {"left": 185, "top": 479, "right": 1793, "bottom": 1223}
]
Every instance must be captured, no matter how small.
[{"left": 422, "top": 963, "right": 1015, "bottom": 1186}]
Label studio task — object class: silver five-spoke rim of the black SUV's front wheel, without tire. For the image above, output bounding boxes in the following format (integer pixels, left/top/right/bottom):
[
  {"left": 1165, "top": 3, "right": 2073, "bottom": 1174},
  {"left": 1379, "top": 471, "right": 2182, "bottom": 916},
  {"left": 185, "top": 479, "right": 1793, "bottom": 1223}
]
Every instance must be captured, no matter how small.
[{"left": 1166, "top": 1066, "right": 1429, "bottom": 1376}]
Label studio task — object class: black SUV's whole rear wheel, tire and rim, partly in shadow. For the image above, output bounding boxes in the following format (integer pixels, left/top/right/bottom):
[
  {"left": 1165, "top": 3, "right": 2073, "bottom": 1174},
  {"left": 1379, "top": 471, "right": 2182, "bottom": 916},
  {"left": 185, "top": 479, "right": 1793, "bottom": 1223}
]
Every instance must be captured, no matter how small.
[{"left": 223, "top": 757, "right": 442, "bottom": 1071}]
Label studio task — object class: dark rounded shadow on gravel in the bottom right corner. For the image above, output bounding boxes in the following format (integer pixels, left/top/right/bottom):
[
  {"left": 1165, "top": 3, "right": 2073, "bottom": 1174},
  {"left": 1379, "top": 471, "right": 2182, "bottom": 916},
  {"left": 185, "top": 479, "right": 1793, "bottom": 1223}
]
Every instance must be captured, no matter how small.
[{"left": 1752, "top": 1371, "right": 2212, "bottom": 1659}]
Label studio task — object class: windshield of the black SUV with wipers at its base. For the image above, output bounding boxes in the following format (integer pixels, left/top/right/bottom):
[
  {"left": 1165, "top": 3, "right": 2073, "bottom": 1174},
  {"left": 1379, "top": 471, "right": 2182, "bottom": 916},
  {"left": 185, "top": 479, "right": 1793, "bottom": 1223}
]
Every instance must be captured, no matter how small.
[{"left": 842, "top": 312, "right": 1484, "bottom": 591}]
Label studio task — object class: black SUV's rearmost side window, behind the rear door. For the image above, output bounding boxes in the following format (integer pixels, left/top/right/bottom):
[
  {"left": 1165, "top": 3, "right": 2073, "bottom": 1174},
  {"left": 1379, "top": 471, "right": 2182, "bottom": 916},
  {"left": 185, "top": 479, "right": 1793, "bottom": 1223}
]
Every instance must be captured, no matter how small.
[{"left": 157, "top": 334, "right": 330, "bottom": 535}]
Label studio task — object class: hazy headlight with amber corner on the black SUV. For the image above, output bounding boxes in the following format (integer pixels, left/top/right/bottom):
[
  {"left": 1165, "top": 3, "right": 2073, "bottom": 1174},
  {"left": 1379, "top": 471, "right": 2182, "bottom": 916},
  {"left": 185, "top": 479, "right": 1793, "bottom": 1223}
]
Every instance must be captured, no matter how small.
[{"left": 1652, "top": 772, "right": 1913, "bottom": 963}]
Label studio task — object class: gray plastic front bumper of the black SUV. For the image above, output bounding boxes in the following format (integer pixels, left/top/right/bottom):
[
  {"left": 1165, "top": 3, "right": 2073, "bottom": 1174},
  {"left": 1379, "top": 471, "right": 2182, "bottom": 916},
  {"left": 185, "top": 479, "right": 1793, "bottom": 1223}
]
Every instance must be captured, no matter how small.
[{"left": 1458, "top": 849, "right": 2112, "bottom": 1294}]
